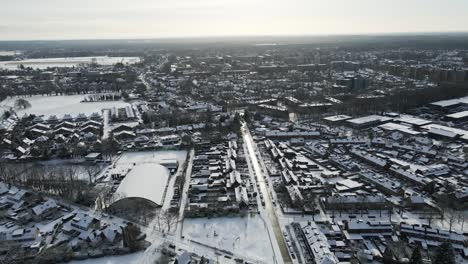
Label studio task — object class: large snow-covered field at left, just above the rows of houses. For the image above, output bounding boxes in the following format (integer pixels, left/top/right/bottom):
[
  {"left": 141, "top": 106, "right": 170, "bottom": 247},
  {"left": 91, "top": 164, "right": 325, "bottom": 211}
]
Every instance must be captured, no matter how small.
[{"left": 0, "top": 95, "right": 129, "bottom": 118}]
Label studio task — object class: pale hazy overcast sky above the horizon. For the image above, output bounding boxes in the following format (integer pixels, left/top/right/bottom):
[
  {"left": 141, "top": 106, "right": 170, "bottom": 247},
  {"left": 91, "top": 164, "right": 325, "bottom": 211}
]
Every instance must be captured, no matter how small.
[{"left": 0, "top": 0, "right": 468, "bottom": 40}]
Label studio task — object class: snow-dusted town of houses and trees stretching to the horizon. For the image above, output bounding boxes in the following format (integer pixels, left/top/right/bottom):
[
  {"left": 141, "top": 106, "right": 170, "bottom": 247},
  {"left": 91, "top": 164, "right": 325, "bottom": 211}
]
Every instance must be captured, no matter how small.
[{"left": 0, "top": 35, "right": 468, "bottom": 264}]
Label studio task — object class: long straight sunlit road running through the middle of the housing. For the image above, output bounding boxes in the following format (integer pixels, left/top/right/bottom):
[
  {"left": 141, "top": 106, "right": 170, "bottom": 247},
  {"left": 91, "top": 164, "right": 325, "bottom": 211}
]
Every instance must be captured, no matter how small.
[{"left": 242, "top": 124, "right": 293, "bottom": 263}]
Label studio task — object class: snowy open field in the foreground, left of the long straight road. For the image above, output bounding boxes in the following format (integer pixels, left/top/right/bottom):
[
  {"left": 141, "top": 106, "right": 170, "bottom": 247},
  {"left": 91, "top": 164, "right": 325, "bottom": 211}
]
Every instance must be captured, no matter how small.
[{"left": 183, "top": 215, "right": 273, "bottom": 263}]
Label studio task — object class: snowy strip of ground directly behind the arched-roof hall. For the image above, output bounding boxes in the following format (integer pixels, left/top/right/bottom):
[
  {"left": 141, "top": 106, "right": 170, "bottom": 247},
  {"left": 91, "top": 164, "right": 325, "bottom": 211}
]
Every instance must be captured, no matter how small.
[{"left": 117, "top": 150, "right": 187, "bottom": 165}]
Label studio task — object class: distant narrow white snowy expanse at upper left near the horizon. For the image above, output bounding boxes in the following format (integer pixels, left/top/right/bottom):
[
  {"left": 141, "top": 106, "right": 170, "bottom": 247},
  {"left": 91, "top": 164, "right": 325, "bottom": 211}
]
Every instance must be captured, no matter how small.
[{"left": 0, "top": 56, "right": 140, "bottom": 70}]
